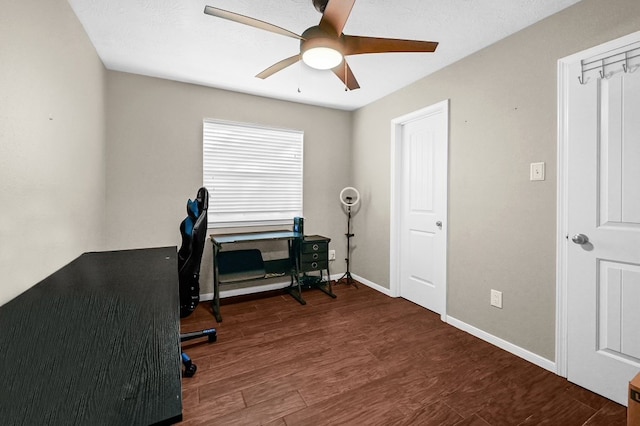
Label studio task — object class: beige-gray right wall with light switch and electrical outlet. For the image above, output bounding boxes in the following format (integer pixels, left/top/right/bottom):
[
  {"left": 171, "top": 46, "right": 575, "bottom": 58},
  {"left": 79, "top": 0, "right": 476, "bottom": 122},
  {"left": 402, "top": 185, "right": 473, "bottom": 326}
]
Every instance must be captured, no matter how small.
[{"left": 353, "top": 0, "right": 640, "bottom": 360}]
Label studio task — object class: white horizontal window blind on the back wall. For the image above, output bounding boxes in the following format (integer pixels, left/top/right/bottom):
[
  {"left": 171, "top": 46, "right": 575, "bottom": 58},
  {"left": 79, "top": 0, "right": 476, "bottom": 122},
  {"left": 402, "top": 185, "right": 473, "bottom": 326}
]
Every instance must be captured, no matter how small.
[{"left": 203, "top": 119, "right": 303, "bottom": 228}]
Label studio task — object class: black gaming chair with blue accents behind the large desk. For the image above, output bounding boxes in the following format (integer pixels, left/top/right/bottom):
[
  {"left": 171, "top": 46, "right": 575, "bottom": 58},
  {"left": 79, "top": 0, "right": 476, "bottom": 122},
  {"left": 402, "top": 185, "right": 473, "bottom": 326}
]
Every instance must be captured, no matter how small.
[{"left": 178, "top": 188, "right": 217, "bottom": 377}]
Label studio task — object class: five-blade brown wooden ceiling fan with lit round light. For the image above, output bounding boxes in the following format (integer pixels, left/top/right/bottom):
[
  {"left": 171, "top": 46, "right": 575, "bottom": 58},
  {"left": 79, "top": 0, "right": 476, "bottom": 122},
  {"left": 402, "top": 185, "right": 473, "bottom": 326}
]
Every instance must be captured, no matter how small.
[{"left": 204, "top": 0, "right": 438, "bottom": 90}]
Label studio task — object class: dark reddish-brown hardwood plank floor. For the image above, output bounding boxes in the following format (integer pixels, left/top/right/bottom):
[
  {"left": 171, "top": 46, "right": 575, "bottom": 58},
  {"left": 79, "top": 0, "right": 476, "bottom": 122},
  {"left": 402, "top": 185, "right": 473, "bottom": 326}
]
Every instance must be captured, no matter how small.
[{"left": 181, "top": 284, "right": 626, "bottom": 426}]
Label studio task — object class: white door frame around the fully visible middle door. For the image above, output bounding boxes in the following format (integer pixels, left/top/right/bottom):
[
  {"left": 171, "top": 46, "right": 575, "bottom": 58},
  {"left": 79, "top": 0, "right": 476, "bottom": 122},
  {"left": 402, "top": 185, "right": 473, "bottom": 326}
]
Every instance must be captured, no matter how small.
[{"left": 389, "top": 99, "right": 449, "bottom": 321}]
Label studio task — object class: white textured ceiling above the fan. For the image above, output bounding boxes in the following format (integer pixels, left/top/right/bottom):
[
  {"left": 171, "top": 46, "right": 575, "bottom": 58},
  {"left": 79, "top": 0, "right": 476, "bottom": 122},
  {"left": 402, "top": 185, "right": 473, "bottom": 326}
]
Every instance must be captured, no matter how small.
[{"left": 68, "top": 0, "right": 578, "bottom": 110}]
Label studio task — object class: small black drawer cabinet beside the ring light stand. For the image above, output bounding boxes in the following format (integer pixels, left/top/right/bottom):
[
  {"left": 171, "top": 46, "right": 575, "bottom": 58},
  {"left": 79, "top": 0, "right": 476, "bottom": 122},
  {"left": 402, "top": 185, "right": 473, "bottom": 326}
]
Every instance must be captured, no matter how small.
[{"left": 295, "top": 235, "right": 336, "bottom": 297}]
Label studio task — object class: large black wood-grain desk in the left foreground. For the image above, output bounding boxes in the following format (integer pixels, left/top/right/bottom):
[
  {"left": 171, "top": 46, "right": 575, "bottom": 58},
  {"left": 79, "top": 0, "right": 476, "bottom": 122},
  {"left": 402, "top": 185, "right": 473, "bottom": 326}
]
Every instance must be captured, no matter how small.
[{"left": 0, "top": 247, "right": 182, "bottom": 425}]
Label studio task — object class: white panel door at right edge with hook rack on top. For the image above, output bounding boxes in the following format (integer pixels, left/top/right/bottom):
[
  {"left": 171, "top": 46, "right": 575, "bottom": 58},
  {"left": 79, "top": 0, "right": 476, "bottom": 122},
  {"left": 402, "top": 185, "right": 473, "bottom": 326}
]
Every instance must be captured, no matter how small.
[{"left": 566, "top": 38, "right": 640, "bottom": 405}]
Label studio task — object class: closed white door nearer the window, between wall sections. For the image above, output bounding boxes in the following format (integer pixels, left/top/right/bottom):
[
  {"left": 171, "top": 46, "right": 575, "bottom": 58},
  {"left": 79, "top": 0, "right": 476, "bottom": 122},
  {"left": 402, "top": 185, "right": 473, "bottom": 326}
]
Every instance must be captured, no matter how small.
[{"left": 396, "top": 102, "right": 448, "bottom": 316}]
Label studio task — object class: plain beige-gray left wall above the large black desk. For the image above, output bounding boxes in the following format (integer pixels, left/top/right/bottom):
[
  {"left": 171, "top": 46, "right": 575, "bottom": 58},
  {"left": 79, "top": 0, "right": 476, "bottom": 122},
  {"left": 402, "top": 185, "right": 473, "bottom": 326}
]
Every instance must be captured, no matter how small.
[{"left": 0, "top": 0, "right": 105, "bottom": 305}]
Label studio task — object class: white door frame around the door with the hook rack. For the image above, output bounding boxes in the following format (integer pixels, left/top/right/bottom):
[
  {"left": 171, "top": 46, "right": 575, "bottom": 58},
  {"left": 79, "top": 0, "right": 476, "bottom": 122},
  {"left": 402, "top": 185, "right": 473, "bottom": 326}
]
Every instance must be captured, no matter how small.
[{"left": 556, "top": 31, "right": 640, "bottom": 377}]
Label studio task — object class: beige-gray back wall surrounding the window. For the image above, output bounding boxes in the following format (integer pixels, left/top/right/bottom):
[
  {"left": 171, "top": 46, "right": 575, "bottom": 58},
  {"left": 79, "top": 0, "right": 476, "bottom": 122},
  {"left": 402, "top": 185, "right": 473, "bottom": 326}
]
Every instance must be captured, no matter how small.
[{"left": 105, "top": 71, "right": 352, "bottom": 293}]
